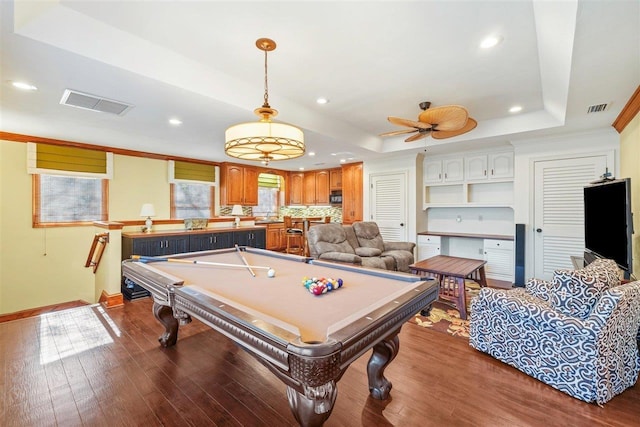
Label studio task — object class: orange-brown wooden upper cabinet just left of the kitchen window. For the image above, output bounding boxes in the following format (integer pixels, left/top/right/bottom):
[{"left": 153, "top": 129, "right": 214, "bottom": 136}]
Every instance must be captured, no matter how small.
[{"left": 220, "top": 163, "right": 259, "bottom": 206}]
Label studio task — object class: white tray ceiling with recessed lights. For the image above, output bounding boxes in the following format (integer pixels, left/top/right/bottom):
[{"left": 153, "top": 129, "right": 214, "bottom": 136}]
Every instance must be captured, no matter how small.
[{"left": 0, "top": 0, "right": 640, "bottom": 170}]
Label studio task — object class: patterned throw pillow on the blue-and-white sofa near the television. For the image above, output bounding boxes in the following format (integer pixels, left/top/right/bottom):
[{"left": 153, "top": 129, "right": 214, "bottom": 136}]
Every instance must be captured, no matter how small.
[{"left": 551, "top": 259, "right": 620, "bottom": 320}]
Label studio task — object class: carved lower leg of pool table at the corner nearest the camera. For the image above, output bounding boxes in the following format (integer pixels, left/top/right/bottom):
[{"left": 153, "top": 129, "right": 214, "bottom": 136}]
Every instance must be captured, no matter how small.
[{"left": 287, "top": 381, "right": 338, "bottom": 427}]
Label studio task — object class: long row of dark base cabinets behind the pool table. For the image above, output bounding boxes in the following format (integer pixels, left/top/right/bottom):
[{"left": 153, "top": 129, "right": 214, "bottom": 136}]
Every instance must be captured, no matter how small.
[{"left": 121, "top": 228, "right": 267, "bottom": 300}]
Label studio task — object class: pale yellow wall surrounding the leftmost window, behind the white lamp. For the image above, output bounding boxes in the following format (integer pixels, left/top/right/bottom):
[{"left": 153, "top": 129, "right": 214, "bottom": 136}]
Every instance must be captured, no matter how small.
[{"left": 0, "top": 141, "right": 170, "bottom": 314}]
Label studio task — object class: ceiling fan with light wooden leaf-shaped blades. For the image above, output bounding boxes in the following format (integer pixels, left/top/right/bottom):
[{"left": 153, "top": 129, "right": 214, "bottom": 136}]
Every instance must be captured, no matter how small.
[{"left": 380, "top": 102, "right": 478, "bottom": 142}]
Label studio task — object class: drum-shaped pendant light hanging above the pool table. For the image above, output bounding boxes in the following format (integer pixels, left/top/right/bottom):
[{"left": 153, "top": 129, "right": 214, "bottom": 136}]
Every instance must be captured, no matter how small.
[{"left": 224, "top": 38, "right": 305, "bottom": 165}]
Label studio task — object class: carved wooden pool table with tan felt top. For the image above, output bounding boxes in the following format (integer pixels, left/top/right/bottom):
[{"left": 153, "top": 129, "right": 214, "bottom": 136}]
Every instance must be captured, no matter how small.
[{"left": 122, "top": 247, "right": 438, "bottom": 426}]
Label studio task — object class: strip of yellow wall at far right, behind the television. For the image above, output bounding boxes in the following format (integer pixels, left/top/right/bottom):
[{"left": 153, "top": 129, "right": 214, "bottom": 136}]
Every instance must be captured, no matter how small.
[{"left": 620, "top": 114, "right": 640, "bottom": 277}]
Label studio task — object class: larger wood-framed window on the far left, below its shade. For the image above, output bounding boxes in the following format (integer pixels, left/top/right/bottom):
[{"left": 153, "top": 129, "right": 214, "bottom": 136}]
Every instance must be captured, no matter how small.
[{"left": 33, "top": 174, "right": 109, "bottom": 227}]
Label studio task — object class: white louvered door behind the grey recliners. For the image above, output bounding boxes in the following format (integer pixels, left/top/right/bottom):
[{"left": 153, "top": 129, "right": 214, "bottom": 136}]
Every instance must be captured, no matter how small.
[{"left": 371, "top": 173, "right": 409, "bottom": 242}]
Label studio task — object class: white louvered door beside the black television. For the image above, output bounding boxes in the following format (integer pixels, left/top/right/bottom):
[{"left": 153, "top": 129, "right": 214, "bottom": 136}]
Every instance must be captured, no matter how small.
[{"left": 533, "top": 155, "right": 607, "bottom": 280}]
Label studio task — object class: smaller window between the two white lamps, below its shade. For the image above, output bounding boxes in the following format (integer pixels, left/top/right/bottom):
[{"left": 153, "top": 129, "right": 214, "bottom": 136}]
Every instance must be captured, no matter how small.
[{"left": 171, "top": 182, "right": 215, "bottom": 219}]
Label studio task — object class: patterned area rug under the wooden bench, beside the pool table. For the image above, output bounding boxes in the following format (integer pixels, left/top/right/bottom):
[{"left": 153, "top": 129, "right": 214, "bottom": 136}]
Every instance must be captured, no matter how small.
[{"left": 413, "top": 280, "right": 480, "bottom": 338}]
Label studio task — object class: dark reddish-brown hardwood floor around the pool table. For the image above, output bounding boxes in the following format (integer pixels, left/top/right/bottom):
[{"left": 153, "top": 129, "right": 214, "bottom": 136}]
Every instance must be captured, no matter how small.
[{"left": 0, "top": 298, "right": 640, "bottom": 427}]
